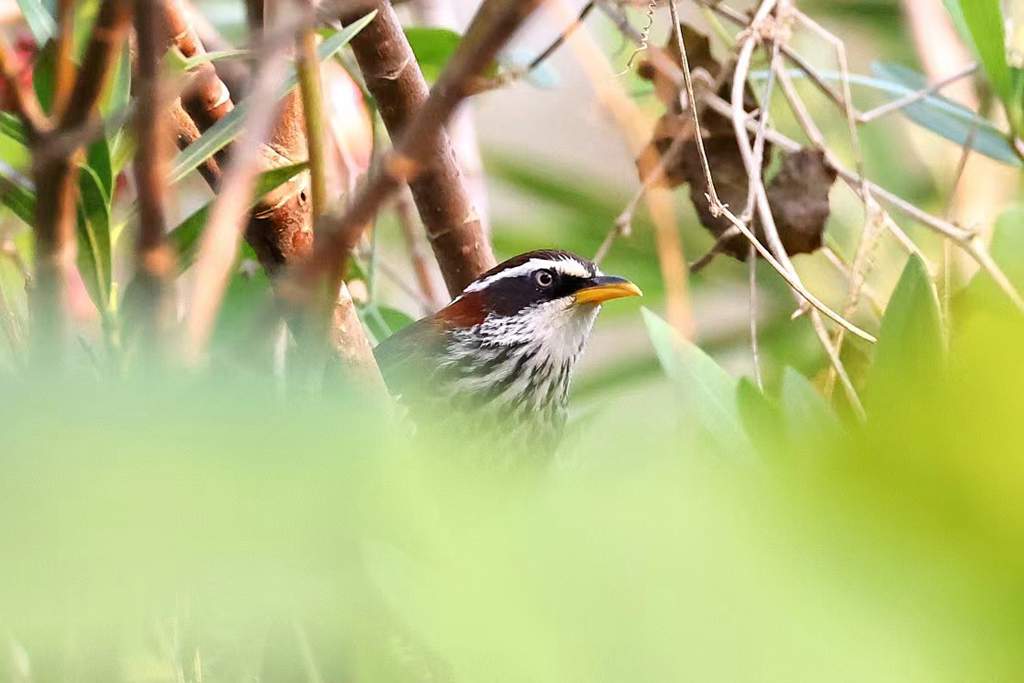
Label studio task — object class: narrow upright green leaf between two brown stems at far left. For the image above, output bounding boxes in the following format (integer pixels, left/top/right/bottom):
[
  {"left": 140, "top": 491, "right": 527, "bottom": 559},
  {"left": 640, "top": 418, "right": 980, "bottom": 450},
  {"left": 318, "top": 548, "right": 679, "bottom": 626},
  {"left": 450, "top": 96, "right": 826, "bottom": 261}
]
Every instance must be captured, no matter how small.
[{"left": 78, "top": 166, "right": 112, "bottom": 312}]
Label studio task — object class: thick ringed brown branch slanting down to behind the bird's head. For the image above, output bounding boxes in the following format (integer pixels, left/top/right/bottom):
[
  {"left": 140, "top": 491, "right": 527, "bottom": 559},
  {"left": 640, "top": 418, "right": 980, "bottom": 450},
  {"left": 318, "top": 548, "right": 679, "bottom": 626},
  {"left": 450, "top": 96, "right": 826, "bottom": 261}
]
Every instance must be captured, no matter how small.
[{"left": 352, "top": 0, "right": 497, "bottom": 295}]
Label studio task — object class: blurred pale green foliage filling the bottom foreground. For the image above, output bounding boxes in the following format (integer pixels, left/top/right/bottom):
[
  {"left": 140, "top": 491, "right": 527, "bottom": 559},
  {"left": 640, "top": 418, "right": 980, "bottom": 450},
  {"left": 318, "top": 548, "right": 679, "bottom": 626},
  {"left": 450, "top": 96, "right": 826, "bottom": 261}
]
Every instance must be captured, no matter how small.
[{"left": 0, "top": 252, "right": 1024, "bottom": 681}]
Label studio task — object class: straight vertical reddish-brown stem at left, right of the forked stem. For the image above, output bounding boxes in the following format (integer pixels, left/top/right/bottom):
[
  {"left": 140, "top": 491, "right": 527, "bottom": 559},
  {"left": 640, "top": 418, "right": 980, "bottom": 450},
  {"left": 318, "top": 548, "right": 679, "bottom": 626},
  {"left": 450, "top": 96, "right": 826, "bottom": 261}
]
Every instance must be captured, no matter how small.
[{"left": 133, "top": 0, "right": 175, "bottom": 346}]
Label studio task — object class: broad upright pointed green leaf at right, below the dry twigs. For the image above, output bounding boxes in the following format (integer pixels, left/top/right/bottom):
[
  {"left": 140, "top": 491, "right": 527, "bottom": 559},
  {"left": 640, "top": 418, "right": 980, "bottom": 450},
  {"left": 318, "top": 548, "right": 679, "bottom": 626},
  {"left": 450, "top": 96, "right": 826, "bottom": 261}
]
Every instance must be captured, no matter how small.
[{"left": 864, "top": 255, "right": 944, "bottom": 410}]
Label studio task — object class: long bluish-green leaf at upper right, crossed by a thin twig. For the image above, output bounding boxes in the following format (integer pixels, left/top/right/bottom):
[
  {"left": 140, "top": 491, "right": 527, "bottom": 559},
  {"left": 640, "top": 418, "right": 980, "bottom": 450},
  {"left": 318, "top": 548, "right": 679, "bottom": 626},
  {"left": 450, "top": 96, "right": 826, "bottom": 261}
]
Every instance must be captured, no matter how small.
[{"left": 871, "top": 62, "right": 1022, "bottom": 166}]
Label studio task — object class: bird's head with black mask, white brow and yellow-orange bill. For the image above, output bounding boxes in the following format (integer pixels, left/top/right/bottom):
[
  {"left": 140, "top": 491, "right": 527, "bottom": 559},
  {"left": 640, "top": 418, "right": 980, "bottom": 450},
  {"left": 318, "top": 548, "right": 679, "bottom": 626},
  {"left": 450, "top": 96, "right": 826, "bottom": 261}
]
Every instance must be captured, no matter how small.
[{"left": 438, "top": 250, "right": 640, "bottom": 355}]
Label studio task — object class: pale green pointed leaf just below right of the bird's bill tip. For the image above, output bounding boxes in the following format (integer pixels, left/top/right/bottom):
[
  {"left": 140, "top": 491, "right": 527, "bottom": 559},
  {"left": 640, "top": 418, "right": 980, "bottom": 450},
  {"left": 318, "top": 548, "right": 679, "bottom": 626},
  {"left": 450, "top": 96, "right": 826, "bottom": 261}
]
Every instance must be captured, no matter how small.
[{"left": 641, "top": 308, "right": 748, "bottom": 452}]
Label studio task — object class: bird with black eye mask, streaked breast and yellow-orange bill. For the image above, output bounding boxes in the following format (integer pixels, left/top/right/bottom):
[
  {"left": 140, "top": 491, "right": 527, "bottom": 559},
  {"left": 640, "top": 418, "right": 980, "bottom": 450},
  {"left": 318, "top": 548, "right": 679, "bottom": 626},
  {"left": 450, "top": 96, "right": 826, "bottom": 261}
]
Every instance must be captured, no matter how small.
[{"left": 374, "top": 249, "right": 642, "bottom": 458}]
